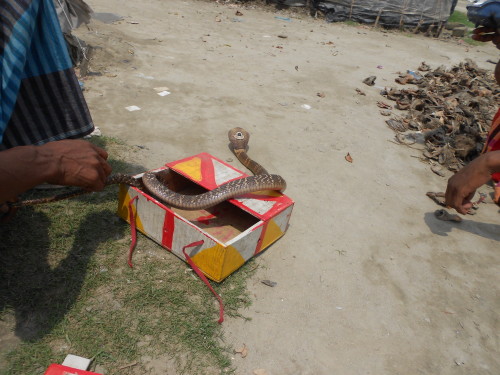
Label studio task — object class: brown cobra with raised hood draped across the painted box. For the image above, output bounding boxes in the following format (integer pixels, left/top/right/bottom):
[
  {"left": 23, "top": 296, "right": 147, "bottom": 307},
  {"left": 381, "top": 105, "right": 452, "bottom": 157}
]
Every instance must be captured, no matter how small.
[{"left": 12, "top": 128, "right": 286, "bottom": 210}]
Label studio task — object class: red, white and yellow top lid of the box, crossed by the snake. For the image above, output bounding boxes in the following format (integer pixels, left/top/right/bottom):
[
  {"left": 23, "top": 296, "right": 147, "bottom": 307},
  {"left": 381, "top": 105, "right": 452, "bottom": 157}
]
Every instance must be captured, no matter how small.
[{"left": 166, "top": 152, "right": 293, "bottom": 221}]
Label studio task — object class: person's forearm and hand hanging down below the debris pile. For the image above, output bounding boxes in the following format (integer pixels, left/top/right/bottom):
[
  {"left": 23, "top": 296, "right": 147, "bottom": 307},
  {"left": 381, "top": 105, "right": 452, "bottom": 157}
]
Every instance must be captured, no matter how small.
[{"left": 445, "top": 151, "right": 500, "bottom": 214}]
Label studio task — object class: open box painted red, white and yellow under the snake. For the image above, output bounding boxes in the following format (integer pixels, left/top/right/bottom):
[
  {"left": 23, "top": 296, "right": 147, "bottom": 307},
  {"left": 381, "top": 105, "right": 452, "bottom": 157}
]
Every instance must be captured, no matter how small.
[{"left": 118, "top": 153, "right": 294, "bottom": 282}]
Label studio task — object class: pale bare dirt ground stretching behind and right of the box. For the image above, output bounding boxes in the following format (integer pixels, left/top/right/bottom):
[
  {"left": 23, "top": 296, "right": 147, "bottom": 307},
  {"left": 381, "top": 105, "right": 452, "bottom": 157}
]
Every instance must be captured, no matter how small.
[{"left": 26, "top": 0, "right": 500, "bottom": 375}]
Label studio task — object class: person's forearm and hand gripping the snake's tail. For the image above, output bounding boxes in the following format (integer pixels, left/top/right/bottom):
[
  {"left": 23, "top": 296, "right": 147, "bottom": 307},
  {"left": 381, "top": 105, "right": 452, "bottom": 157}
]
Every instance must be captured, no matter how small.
[{"left": 0, "top": 140, "right": 111, "bottom": 202}]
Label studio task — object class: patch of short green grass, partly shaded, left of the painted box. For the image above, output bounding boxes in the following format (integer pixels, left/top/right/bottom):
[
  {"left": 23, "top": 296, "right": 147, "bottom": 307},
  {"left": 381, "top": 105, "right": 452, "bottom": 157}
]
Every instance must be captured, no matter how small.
[{"left": 0, "top": 138, "right": 255, "bottom": 375}]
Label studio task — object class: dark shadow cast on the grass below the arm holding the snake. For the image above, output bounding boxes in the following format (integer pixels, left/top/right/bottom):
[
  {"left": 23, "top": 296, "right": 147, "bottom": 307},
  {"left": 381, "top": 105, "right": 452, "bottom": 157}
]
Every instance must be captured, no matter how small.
[{"left": 0, "top": 209, "right": 109, "bottom": 340}]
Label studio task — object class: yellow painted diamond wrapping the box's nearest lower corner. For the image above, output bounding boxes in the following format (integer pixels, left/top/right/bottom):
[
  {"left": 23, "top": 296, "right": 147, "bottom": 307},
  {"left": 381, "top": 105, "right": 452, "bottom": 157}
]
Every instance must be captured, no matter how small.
[{"left": 191, "top": 244, "right": 245, "bottom": 281}]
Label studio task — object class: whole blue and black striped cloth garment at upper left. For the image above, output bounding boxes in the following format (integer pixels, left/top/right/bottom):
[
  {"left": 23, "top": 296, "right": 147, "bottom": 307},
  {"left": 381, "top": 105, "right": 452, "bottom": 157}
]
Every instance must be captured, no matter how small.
[{"left": 0, "top": 0, "right": 94, "bottom": 149}]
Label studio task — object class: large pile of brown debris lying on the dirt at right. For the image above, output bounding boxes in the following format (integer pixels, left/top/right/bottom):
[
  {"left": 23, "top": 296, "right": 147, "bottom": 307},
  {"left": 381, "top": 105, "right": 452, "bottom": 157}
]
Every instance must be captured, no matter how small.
[{"left": 379, "top": 60, "right": 500, "bottom": 171}]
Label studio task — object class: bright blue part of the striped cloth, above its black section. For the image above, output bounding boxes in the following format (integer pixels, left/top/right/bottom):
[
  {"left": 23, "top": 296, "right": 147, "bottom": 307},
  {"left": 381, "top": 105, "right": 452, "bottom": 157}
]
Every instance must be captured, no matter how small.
[{"left": 0, "top": 0, "right": 71, "bottom": 142}]
